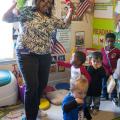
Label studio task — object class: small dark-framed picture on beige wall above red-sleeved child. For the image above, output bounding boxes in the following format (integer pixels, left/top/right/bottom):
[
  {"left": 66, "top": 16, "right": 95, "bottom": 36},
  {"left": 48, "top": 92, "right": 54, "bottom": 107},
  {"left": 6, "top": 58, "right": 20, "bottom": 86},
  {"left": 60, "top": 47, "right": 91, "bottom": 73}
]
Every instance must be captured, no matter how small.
[{"left": 75, "top": 31, "right": 85, "bottom": 47}]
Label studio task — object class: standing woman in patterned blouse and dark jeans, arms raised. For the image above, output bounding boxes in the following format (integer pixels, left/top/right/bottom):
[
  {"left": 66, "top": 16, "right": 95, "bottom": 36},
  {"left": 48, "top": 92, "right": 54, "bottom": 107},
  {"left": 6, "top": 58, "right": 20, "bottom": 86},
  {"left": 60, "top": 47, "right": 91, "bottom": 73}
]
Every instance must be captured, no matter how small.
[{"left": 3, "top": 0, "right": 72, "bottom": 120}]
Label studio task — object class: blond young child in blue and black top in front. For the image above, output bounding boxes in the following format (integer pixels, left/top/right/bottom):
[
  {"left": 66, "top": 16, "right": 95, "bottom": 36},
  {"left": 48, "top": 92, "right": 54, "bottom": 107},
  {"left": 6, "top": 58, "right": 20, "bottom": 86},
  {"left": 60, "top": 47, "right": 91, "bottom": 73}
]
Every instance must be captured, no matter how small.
[{"left": 62, "top": 77, "right": 92, "bottom": 120}]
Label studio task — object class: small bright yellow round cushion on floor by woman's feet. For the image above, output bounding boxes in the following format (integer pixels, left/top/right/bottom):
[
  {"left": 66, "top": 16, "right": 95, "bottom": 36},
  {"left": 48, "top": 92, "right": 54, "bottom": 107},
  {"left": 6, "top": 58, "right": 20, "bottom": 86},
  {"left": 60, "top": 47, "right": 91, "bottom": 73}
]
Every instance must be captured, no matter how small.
[{"left": 39, "top": 98, "right": 50, "bottom": 110}]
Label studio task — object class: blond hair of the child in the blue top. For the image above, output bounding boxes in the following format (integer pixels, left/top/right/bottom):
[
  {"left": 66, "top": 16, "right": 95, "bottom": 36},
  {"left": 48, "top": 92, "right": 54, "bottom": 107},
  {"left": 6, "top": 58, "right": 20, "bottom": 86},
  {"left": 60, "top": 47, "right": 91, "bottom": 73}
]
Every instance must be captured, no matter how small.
[{"left": 70, "top": 75, "right": 88, "bottom": 93}]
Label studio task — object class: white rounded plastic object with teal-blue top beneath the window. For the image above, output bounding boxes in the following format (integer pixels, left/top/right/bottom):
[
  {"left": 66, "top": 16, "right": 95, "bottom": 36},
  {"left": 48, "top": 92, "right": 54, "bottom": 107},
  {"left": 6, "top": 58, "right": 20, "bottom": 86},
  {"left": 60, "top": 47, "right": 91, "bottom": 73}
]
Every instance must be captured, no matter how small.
[{"left": 0, "top": 70, "right": 18, "bottom": 106}]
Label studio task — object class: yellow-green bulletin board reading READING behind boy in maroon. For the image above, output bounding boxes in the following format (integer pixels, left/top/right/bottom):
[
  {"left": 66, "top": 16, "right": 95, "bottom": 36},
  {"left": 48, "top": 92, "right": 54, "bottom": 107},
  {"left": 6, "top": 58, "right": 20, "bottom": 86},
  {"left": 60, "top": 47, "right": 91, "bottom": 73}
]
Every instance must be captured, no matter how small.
[{"left": 92, "top": 0, "right": 120, "bottom": 49}]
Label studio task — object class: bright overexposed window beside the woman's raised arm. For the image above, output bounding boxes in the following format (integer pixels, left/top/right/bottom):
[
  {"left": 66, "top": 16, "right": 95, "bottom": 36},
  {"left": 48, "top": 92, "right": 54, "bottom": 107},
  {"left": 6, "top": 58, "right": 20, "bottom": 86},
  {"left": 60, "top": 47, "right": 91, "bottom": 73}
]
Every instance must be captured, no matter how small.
[{"left": 0, "top": 0, "right": 14, "bottom": 61}]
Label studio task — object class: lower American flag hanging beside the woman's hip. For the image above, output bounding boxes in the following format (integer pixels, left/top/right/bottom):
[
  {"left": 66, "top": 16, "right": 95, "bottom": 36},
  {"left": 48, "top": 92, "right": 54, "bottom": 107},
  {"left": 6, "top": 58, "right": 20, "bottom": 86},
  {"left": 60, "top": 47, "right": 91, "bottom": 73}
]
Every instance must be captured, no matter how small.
[{"left": 51, "top": 30, "right": 66, "bottom": 54}]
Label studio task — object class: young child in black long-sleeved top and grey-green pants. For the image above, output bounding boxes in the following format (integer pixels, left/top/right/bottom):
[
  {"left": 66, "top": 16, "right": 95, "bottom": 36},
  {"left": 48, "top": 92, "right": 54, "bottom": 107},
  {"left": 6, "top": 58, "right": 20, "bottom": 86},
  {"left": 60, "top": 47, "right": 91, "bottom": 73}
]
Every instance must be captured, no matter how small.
[{"left": 86, "top": 52, "right": 105, "bottom": 114}]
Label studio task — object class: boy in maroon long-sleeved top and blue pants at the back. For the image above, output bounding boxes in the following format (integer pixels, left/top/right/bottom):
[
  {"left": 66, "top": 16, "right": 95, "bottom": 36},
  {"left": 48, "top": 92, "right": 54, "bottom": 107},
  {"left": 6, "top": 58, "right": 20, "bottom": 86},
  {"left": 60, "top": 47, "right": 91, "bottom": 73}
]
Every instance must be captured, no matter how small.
[{"left": 101, "top": 33, "right": 120, "bottom": 102}]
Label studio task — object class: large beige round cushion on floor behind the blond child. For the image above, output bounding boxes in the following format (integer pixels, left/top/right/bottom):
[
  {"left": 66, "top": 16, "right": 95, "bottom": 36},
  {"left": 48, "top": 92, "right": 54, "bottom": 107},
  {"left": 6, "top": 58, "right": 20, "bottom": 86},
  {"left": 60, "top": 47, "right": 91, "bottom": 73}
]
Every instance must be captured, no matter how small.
[{"left": 47, "top": 90, "right": 68, "bottom": 105}]
